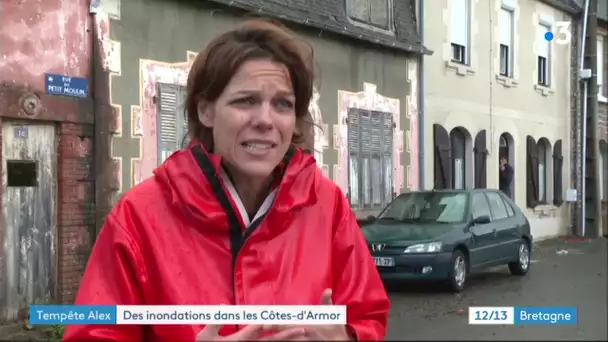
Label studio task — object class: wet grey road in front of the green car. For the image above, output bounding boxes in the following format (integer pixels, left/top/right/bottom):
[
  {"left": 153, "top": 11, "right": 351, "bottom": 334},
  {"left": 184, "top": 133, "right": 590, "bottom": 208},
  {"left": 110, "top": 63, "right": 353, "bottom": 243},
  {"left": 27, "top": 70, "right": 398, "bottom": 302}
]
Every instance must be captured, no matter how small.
[{"left": 387, "top": 239, "right": 608, "bottom": 341}]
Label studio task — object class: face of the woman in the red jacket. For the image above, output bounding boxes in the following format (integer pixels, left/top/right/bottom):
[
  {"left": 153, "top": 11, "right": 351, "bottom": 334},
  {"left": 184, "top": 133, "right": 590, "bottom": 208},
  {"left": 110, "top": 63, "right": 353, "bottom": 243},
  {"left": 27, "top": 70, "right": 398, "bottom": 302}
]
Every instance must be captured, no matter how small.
[{"left": 199, "top": 60, "right": 296, "bottom": 178}]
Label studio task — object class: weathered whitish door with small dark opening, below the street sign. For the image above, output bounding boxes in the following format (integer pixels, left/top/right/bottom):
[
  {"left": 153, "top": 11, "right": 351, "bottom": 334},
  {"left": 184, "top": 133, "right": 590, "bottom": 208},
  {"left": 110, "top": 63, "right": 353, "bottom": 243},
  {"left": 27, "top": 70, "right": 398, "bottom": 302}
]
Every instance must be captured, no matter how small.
[{"left": 0, "top": 121, "right": 57, "bottom": 321}]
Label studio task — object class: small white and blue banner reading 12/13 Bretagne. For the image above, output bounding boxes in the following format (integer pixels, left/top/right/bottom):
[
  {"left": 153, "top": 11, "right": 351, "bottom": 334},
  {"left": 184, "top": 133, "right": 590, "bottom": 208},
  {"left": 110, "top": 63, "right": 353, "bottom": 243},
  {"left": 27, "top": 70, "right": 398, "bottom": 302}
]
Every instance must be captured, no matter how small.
[{"left": 469, "top": 306, "right": 578, "bottom": 325}]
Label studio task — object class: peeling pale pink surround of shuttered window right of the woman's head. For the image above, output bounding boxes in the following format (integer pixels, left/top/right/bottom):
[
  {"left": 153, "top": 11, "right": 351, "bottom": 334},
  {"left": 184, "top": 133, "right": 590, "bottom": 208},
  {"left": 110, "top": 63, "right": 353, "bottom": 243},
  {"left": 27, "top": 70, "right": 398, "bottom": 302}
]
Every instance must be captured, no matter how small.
[{"left": 333, "top": 83, "right": 404, "bottom": 193}]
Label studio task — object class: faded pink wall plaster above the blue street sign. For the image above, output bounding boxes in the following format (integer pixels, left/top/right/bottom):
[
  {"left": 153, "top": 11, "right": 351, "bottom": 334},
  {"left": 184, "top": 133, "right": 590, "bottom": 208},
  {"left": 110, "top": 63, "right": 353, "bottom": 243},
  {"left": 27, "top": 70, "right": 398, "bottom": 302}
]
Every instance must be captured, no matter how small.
[{"left": 0, "top": 0, "right": 91, "bottom": 91}]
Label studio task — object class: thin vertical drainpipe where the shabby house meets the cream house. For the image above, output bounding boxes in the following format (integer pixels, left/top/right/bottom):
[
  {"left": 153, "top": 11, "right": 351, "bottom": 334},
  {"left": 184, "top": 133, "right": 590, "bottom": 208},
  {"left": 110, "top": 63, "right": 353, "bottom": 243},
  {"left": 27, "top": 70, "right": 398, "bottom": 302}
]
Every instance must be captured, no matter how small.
[{"left": 418, "top": 0, "right": 426, "bottom": 190}]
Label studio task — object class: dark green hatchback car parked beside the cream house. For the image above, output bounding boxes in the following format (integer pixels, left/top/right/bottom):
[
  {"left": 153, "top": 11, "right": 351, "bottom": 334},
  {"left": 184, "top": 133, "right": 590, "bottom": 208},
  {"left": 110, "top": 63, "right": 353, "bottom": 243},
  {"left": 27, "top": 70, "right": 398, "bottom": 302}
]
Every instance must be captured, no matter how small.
[{"left": 362, "top": 189, "right": 532, "bottom": 292}]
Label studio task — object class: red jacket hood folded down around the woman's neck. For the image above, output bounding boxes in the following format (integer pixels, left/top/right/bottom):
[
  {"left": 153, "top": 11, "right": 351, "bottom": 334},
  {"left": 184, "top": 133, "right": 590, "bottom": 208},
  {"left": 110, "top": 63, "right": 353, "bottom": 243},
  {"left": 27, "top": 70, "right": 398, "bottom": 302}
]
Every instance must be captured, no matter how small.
[{"left": 154, "top": 143, "right": 321, "bottom": 227}]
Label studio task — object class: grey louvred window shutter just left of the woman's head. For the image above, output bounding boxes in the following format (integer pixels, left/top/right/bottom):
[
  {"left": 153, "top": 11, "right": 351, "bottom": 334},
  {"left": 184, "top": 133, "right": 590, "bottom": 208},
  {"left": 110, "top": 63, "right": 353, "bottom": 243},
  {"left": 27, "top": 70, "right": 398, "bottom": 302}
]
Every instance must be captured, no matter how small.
[{"left": 156, "top": 83, "right": 188, "bottom": 165}]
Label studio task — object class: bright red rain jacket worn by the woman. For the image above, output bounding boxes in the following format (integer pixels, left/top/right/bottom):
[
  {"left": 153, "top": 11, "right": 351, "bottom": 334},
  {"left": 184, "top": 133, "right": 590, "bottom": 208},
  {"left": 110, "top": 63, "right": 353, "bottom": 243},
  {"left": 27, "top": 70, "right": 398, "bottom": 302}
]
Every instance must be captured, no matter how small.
[{"left": 63, "top": 145, "right": 390, "bottom": 342}]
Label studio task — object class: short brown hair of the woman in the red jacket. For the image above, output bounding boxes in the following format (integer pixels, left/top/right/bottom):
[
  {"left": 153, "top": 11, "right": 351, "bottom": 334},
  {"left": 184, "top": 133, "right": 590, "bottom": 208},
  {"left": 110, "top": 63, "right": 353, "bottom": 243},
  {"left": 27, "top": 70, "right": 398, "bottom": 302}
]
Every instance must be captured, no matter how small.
[{"left": 185, "top": 18, "right": 315, "bottom": 151}]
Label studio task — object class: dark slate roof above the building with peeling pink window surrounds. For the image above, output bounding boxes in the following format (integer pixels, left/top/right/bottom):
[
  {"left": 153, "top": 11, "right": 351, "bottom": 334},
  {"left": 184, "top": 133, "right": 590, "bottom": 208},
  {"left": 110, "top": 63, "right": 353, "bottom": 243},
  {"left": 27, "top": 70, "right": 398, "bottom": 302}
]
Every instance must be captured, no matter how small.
[{"left": 210, "top": 0, "right": 432, "bottom": 55}]
